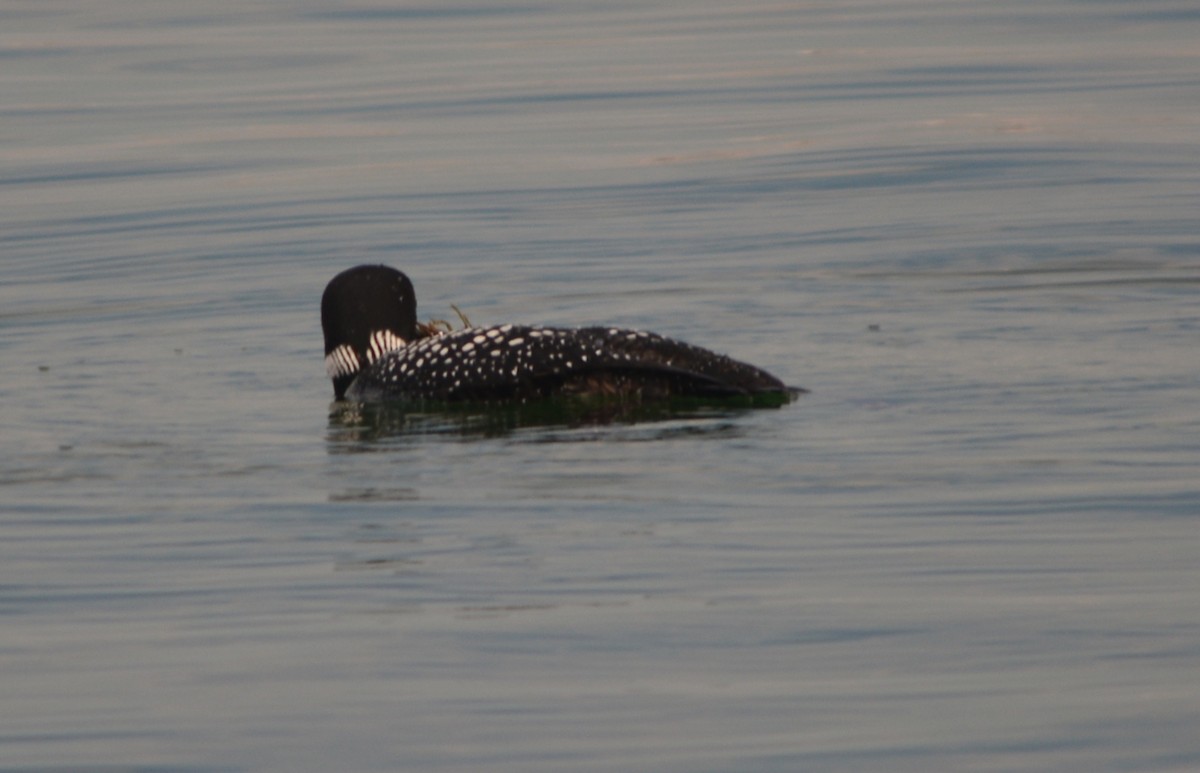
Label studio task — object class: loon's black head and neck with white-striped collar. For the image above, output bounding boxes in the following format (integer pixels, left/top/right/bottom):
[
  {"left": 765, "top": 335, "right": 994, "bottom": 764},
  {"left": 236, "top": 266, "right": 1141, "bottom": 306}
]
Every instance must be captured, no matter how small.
[{"left": 320, "top": 265, "right": 416, "bottom": 400}]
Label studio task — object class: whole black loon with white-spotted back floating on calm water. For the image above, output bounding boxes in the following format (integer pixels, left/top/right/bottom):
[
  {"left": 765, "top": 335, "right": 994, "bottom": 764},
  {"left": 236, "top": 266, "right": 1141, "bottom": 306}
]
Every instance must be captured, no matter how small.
[{"left": 320, "top": 265, "right": 805, "bottom": 405}]
